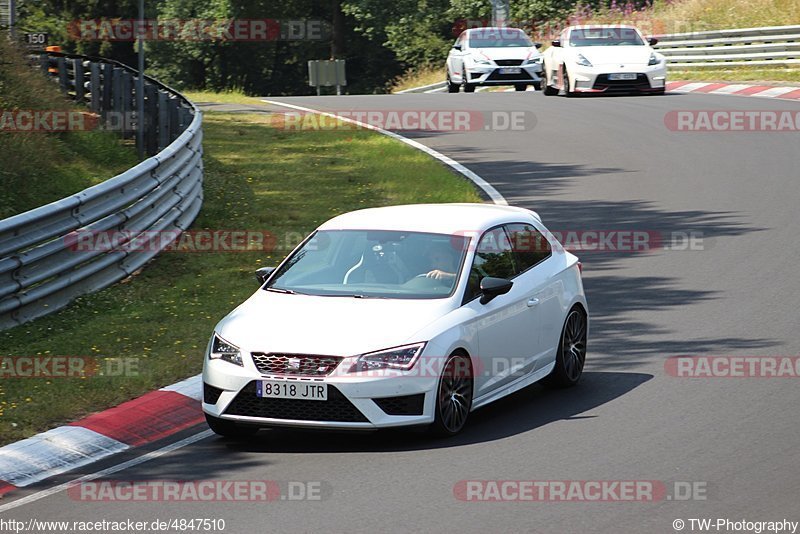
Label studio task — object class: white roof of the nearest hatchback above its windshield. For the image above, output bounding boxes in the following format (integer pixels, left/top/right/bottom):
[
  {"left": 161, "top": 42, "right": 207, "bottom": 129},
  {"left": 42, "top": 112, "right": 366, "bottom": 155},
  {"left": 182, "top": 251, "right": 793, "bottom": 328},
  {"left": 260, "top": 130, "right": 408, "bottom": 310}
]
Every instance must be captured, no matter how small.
[{"left": 319, "top": 204, "right": 541, "bottom": 235}]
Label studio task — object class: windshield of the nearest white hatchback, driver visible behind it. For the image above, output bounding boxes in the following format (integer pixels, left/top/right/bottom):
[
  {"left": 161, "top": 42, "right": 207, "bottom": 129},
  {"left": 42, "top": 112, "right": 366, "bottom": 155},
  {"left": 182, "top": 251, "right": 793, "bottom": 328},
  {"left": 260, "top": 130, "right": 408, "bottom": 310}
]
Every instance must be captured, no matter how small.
[{"left": 264, "top": 230, "right": 468, "bottom": 299}]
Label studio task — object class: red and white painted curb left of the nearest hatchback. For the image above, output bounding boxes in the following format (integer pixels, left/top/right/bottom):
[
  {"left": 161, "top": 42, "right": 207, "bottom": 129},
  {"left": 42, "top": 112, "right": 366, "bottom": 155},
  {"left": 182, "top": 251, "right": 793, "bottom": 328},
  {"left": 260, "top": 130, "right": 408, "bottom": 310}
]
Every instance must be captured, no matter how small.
[{"left": 0, "top": 375, "right": 204, "bottom": 496}]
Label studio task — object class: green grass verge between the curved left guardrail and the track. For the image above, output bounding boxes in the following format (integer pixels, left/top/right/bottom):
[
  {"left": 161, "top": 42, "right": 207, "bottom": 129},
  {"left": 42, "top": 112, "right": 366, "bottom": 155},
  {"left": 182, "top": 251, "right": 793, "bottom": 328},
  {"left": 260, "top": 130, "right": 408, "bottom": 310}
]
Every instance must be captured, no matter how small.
[{"left": 0, "top": 105, "right": 481, "bottom": 444}]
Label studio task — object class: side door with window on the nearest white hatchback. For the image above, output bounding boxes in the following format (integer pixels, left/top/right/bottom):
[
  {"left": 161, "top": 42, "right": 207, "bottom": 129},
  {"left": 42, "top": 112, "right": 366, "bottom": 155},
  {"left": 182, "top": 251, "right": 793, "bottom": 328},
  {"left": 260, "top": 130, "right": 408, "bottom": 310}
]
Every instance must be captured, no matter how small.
[{"left": 465, "top": 226, "right": 539, "bottom": 400}]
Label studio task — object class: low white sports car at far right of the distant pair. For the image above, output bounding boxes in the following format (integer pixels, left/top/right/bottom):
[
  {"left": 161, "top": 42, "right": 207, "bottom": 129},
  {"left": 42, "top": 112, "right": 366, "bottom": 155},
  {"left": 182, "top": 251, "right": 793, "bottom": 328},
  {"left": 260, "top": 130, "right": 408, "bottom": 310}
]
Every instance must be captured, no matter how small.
[{"left": 544, "top": 25, "right": 667, "bottom": 96}]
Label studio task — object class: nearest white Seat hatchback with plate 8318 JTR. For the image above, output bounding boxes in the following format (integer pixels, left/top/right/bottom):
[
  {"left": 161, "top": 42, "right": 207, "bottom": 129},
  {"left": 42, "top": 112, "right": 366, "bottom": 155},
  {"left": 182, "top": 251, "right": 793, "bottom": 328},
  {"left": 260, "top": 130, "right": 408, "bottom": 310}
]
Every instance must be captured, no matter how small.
[{"left": 202, "top": 204, "right": 589, "bottom": 436}]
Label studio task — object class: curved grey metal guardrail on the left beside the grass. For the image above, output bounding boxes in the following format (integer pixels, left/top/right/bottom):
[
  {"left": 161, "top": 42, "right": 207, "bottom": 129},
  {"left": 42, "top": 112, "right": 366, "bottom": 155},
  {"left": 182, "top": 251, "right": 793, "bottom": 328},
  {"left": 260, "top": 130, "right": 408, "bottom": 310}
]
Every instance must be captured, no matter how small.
[{"left": 0, "top": 53, "right": 203, "bottom": 329}]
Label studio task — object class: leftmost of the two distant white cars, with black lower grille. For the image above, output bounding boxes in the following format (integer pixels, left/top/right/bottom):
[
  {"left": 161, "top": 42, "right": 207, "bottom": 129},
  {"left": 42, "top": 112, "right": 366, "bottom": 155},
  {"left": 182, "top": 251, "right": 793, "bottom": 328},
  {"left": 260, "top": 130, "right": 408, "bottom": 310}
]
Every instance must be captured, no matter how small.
[{"left": 446, "top": 28, "right": 542, "bottom": 93}]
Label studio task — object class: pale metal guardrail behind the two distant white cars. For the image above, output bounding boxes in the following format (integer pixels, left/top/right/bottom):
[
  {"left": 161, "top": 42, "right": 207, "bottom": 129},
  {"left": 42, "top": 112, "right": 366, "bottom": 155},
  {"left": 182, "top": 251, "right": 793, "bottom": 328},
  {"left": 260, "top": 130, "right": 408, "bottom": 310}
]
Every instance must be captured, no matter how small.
[{"left": 656, "top": 26, "right": 800, "bottom": 67}]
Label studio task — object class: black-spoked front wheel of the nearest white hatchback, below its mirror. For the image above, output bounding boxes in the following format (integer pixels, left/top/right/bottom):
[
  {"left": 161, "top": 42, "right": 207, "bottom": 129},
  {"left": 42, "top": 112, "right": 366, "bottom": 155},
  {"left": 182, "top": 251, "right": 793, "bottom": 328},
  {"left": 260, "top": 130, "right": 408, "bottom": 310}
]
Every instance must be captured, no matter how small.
[{"left": 431, "top": 352, "right": 474, "bottom": 437}]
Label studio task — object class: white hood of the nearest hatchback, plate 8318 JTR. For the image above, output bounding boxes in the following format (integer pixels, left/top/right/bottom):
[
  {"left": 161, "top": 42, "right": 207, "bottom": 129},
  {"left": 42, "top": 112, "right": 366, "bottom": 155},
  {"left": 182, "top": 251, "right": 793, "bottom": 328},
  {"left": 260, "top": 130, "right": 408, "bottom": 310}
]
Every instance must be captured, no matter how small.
[{"left": 215, "top": 290, "right": 455, "bottom": 356}]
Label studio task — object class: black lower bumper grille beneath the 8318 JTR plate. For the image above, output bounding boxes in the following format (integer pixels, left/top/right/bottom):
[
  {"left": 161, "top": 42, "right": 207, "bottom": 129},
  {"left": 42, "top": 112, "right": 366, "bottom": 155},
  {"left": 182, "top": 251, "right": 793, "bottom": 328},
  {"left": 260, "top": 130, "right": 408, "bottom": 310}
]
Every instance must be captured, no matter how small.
[{"left": 225, "top": 382, "right": 369, "bottom": 423}]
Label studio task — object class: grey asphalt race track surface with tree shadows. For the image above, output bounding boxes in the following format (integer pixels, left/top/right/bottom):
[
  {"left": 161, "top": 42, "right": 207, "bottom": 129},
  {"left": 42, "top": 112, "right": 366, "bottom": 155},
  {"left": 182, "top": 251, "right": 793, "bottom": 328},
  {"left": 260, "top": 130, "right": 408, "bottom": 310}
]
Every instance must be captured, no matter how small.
[{"left": 3, "top": 92, "right": 800, "bottom": 533}]
